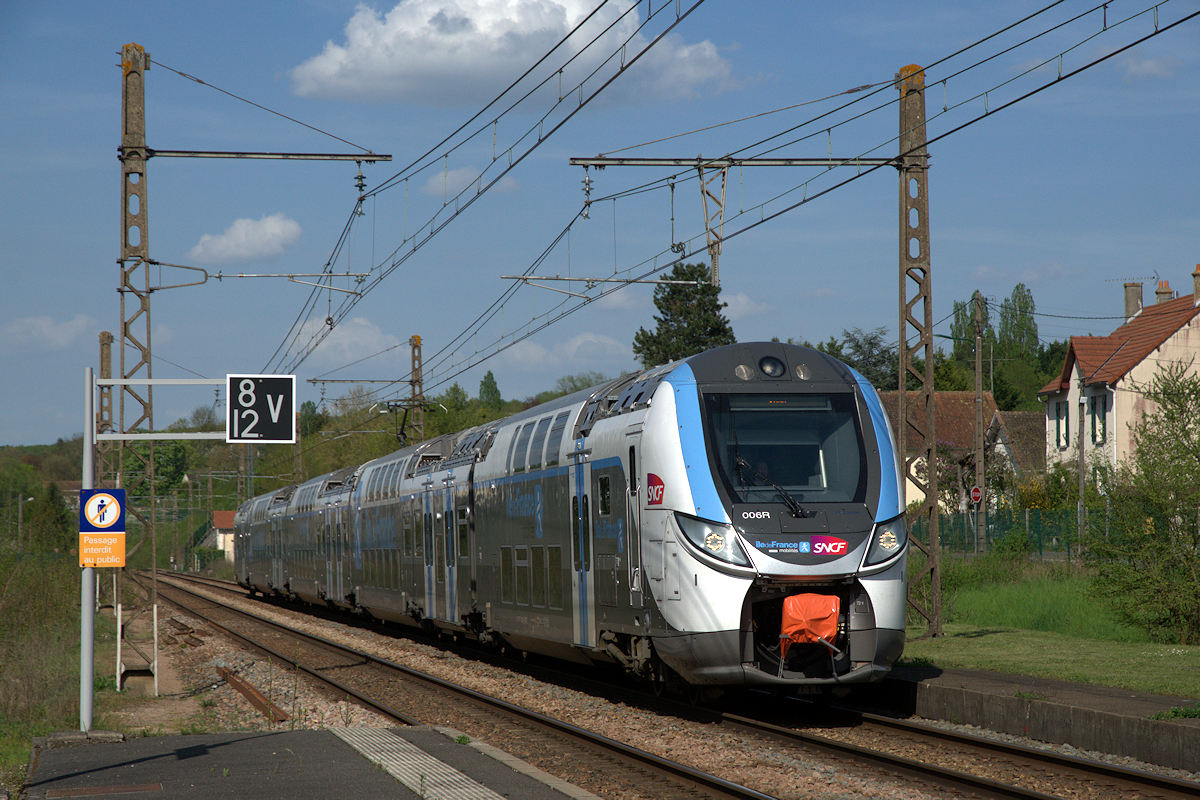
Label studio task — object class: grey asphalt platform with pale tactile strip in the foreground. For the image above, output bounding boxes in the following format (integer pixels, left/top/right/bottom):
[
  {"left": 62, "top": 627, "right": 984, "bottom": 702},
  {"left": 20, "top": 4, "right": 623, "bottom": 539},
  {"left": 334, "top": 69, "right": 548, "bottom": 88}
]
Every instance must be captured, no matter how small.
[{"left": 20, "top": 727, "right": 596, "bottom": 800}]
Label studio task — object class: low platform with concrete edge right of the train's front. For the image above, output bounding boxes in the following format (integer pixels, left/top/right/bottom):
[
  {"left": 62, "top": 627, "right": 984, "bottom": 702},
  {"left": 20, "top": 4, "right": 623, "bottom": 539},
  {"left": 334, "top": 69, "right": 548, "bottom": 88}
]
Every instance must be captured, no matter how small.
[{"left": 869, "top": 667, "right": 1200, "bottom": 771}]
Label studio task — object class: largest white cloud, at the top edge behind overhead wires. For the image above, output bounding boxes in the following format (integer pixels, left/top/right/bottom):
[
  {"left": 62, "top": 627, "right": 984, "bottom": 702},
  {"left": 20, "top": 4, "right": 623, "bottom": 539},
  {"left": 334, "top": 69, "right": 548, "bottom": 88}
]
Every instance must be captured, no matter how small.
[{"left": 292, "top": 0, "right": 730, "bottom": 106}]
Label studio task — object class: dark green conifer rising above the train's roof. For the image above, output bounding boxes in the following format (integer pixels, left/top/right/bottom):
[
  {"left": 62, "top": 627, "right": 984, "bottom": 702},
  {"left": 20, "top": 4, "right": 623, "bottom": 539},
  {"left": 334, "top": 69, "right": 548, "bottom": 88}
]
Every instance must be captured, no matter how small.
[{"left": 634, "top": 264, "right": 737, "bottom": 367}]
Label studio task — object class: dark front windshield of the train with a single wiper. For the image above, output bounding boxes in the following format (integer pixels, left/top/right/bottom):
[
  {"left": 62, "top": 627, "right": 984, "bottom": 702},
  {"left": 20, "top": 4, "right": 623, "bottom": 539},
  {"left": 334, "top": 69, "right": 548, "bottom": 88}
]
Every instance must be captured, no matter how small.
[{"left": 704, "top": 393, "right": 866, "bottom": 503}]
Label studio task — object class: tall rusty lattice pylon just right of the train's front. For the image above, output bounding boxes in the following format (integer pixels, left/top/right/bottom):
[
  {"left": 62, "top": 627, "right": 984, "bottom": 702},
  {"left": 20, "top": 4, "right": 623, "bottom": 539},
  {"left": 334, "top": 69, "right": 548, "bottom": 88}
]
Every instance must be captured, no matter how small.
[{"left": 896, "top": 65, "right": 942, "bottom": 636}]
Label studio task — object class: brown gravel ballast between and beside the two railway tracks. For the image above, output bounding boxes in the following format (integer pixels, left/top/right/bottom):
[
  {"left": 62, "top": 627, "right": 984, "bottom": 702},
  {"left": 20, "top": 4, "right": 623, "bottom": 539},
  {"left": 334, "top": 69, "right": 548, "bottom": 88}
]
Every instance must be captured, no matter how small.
[{"left": 154, "top": 585, "right": 1195, "bottom": 800}]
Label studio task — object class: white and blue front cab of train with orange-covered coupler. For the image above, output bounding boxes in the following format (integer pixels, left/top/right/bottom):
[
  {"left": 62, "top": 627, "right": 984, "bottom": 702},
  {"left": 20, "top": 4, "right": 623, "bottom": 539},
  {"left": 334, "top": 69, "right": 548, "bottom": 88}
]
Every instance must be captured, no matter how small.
[{"left": 647, "top": 344, "right": 907, "bottom": 688}]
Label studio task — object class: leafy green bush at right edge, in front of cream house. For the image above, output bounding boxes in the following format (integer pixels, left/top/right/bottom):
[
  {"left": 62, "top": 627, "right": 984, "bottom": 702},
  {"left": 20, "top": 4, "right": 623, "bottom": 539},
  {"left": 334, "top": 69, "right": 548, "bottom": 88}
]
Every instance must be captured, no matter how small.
[{"left": 1087, "top": 362, "right": 1200, "bottom": 644}]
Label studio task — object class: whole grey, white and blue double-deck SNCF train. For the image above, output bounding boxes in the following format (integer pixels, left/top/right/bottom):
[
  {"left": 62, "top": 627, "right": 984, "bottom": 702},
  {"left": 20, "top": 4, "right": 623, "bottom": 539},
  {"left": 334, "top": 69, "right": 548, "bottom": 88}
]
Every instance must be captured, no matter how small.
[{"left": 234, "top": 342, "right": 908, "bottom": 692}]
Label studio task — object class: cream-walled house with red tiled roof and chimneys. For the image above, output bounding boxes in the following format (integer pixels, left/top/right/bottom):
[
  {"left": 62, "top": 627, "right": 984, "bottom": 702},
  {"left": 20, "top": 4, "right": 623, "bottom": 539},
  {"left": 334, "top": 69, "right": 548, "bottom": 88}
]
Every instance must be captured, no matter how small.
[{"left": 1038, "top": 264, "right": 1200, "bottom": 467}]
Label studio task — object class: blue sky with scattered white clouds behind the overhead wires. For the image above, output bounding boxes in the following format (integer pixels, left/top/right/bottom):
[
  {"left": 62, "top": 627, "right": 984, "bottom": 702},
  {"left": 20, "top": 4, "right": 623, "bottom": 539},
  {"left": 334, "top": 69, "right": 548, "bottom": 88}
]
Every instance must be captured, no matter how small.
[{"left": 0, "top": 0, "right": 1200, "bottom": 444}]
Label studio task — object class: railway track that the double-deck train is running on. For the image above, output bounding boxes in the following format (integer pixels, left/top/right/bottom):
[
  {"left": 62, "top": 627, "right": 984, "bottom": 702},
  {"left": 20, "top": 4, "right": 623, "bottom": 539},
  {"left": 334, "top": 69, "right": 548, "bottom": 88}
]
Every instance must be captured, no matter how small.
[{"left": 150, "top": 579, "right": 1200, "bottom": 800}]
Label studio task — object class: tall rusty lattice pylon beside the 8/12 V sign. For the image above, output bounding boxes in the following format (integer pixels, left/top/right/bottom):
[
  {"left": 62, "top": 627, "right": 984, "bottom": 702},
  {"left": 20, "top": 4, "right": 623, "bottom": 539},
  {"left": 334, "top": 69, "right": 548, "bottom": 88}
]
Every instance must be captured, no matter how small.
[{"left": 116, "top": 44, "right": 157, "bottom": 568}]
